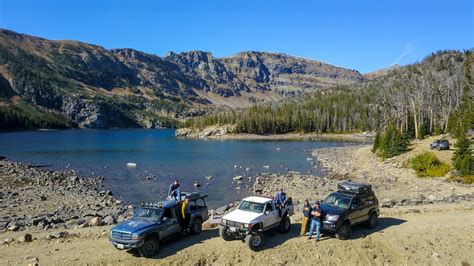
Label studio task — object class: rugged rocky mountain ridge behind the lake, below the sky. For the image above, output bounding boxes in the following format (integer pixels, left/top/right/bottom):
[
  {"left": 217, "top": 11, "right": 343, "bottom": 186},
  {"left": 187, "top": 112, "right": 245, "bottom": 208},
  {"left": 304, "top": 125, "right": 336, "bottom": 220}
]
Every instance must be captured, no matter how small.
[{"left": 0, "top": 29, "right": 367, "bottom": 128}]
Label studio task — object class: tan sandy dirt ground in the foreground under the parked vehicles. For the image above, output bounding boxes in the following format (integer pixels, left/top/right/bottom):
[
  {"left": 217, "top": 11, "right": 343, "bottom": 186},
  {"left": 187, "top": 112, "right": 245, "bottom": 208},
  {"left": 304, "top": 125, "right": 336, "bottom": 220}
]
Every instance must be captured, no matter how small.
[{"left": 0, "top": 203, "right": 474, "bottom": 265}]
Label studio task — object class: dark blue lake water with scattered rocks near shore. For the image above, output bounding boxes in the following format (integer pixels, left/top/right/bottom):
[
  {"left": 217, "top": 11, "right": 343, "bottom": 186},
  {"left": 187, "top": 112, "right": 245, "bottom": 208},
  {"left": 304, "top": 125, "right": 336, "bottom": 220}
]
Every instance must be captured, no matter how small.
[{"left": 0, "top": 129, "right": 362, "bottom": 207}]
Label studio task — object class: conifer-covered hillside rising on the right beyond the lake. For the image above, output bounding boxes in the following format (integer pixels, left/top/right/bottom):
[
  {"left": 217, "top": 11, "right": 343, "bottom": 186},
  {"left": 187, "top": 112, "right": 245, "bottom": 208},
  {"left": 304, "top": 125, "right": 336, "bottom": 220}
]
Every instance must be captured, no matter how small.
[{"left": 185, "top": 50, "right": 474, "bottom": 138}]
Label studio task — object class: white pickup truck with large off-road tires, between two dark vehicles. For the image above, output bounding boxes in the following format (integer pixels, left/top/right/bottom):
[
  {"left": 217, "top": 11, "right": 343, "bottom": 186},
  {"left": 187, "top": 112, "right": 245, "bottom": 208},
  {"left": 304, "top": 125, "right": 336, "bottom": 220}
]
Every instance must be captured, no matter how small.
[{"left": 219, "top": 196, "right": 294, "bottom": 251}]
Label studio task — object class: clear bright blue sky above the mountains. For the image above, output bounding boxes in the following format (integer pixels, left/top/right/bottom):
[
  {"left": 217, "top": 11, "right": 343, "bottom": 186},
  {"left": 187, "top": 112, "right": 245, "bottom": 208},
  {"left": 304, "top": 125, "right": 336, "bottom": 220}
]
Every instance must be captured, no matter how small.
[{"left": 0, "top": 0, "right": 474, "bottom": 73}]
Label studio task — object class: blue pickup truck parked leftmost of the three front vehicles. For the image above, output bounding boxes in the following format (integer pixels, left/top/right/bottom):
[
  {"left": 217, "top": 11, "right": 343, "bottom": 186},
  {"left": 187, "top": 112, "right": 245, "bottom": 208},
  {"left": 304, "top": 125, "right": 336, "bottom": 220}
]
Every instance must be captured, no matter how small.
[{"left": 109, "top": 193, "right": 209, "bottom": 258}]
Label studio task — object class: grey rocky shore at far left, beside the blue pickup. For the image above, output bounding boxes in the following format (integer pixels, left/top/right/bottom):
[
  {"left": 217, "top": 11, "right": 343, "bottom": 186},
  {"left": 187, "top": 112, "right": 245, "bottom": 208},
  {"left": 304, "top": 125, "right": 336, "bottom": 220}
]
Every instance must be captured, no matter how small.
[{"left": 0, "top": 160, "right": 132, "bottom": 232}]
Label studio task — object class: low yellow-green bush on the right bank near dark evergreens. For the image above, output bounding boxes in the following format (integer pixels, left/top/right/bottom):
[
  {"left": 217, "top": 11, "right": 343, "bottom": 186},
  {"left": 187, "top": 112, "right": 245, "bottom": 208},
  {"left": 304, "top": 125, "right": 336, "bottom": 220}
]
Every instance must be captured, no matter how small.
[{"left": 410, "top": 152, "right": 449, "bottom": 177}]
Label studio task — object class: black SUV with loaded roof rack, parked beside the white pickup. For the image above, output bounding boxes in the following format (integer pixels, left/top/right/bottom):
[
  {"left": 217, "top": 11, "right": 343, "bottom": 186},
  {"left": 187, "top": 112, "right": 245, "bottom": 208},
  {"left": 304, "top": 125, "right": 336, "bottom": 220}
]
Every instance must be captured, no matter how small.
[{"left": 321, "top": 182, "right": 380, "bottom": 239}]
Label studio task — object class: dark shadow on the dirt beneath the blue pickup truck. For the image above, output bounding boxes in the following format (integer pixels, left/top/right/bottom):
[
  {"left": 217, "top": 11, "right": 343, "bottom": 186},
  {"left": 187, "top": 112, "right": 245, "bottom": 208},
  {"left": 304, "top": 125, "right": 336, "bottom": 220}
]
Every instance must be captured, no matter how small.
[{"left": 128, "top": 229, "right": 219, "bottom": 259}]
